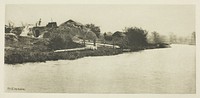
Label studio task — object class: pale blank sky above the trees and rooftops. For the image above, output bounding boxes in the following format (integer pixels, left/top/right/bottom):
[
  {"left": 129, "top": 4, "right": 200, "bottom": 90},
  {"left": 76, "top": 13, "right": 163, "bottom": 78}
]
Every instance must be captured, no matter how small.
[{"left": 5, "top": 5, "right": 195, "bottom": 36}]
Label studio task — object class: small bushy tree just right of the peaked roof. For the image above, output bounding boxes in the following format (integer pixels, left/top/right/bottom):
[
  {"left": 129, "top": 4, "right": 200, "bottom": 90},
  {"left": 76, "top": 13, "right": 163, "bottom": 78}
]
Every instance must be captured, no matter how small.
[{"left": 85, "top": 24, "right": 101, "bottom": 38}]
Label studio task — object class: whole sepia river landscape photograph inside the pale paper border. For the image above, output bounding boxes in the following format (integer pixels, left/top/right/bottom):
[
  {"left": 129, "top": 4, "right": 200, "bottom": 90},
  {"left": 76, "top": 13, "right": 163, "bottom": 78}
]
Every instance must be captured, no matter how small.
[{"left": 3, "top": 1, "right": 196, "bottom": 94}]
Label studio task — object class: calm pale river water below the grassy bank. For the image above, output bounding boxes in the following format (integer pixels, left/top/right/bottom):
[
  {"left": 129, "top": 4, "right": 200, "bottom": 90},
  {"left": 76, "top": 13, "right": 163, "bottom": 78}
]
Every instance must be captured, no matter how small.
[{"left": 5, "top": 45, "right": 196, "bottom": 94}]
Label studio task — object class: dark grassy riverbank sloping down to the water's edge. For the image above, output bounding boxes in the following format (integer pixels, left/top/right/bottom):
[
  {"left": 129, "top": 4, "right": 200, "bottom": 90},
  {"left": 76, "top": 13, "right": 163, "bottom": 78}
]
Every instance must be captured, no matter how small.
[{"left": 4, "top": 34, "right": 170, "bottom": 64}]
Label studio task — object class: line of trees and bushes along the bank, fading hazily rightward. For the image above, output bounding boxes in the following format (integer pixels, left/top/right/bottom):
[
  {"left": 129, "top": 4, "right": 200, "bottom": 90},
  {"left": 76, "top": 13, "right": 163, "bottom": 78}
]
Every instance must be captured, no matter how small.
[{"left": 5, "top": 20, "right": 196, "bottom": 50}]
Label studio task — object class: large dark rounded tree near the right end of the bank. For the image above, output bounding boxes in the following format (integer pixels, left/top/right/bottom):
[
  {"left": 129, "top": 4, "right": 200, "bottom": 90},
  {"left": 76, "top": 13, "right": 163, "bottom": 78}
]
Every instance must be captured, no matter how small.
[{"left": 125, "top": 27, "right": 148, "bottom": 47}]
